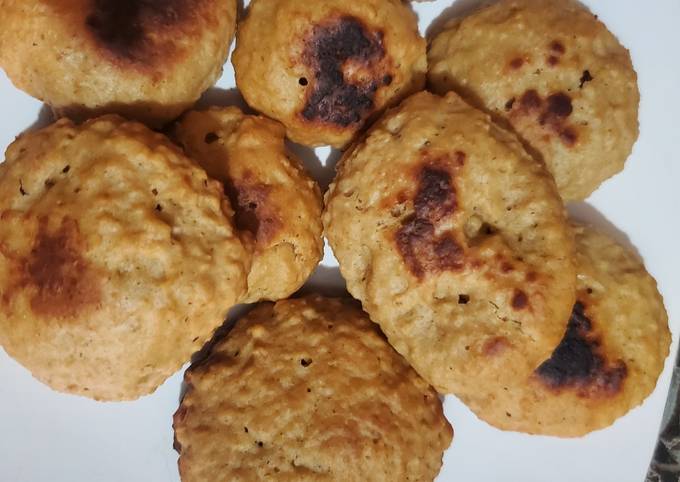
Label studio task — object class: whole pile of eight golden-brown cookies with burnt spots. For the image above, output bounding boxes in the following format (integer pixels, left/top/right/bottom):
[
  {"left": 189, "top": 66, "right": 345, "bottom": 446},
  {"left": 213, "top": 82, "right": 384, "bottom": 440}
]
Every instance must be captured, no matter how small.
[{"left": 0, "top": 0, "right": 670, "bottom": 482}]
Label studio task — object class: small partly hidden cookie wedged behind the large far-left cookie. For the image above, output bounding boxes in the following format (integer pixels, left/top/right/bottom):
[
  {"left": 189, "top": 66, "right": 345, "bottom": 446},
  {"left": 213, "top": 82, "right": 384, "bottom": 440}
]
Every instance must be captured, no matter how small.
[{"left": 175, "top": 107, "right": 323, "bottom": 303}]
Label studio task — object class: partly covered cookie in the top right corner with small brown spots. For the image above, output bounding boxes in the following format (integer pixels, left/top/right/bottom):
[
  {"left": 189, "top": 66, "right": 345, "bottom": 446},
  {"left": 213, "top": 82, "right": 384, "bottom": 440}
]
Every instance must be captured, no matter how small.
[{"left": 428, "top": 0, "right": 640, "bottom": 200}]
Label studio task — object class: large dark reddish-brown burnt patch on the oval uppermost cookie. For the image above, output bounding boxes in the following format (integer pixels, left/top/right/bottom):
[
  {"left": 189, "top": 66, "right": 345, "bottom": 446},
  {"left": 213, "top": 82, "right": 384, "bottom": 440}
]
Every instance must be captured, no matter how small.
[{"left": 395, "top": 160, "right": 464, "bottom": 279}]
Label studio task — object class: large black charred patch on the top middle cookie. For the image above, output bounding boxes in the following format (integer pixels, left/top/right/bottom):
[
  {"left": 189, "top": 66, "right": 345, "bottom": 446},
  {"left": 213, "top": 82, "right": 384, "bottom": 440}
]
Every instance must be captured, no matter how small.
[{"left": 301, "top": 16, "right": 392, "bottom": 127}]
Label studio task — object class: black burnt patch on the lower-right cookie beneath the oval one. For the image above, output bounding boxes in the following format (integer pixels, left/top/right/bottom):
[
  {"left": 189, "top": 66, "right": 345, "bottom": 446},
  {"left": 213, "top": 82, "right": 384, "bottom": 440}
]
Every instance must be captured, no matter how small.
[{"left": 536, "top": 301, "right": 628, "bottom": 398}]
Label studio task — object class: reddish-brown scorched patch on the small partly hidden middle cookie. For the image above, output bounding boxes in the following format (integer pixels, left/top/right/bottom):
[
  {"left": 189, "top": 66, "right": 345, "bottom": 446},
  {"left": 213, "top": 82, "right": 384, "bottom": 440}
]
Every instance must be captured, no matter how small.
[{"left": 224, "top": 180, "right": 281, "bottom": 245}]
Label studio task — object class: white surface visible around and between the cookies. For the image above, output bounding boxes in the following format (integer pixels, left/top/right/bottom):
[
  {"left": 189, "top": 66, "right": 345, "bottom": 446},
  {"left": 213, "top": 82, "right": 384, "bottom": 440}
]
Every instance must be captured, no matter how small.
[{"left": 0, "top": 0, "right": 680, "bottom": 482}]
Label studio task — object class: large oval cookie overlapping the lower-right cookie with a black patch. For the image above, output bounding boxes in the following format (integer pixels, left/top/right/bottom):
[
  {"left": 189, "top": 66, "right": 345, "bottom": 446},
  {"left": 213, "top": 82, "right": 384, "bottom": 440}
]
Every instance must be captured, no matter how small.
[{"left": 324, "top": 92, "right": 576, "bottom": 396}]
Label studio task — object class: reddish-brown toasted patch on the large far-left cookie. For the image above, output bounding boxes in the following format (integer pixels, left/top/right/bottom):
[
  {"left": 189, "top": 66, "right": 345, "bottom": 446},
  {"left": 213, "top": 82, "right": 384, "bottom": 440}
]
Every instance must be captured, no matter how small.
[{"left": 22, "top": 218, "right": 100, "bottom": 318}]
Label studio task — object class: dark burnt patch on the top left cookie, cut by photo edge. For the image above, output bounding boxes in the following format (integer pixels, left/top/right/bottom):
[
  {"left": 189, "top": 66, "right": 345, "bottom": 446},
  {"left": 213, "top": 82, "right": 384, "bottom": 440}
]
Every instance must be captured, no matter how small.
[{"left": 85, "top": 0, "right": 191, "bottom": 63}]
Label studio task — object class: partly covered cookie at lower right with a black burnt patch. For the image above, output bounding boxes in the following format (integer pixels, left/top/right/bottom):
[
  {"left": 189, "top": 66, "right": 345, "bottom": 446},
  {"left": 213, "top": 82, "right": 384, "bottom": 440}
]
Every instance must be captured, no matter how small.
[{"left": 464, "top": 223, "right": 671, "bottom": 437}]
